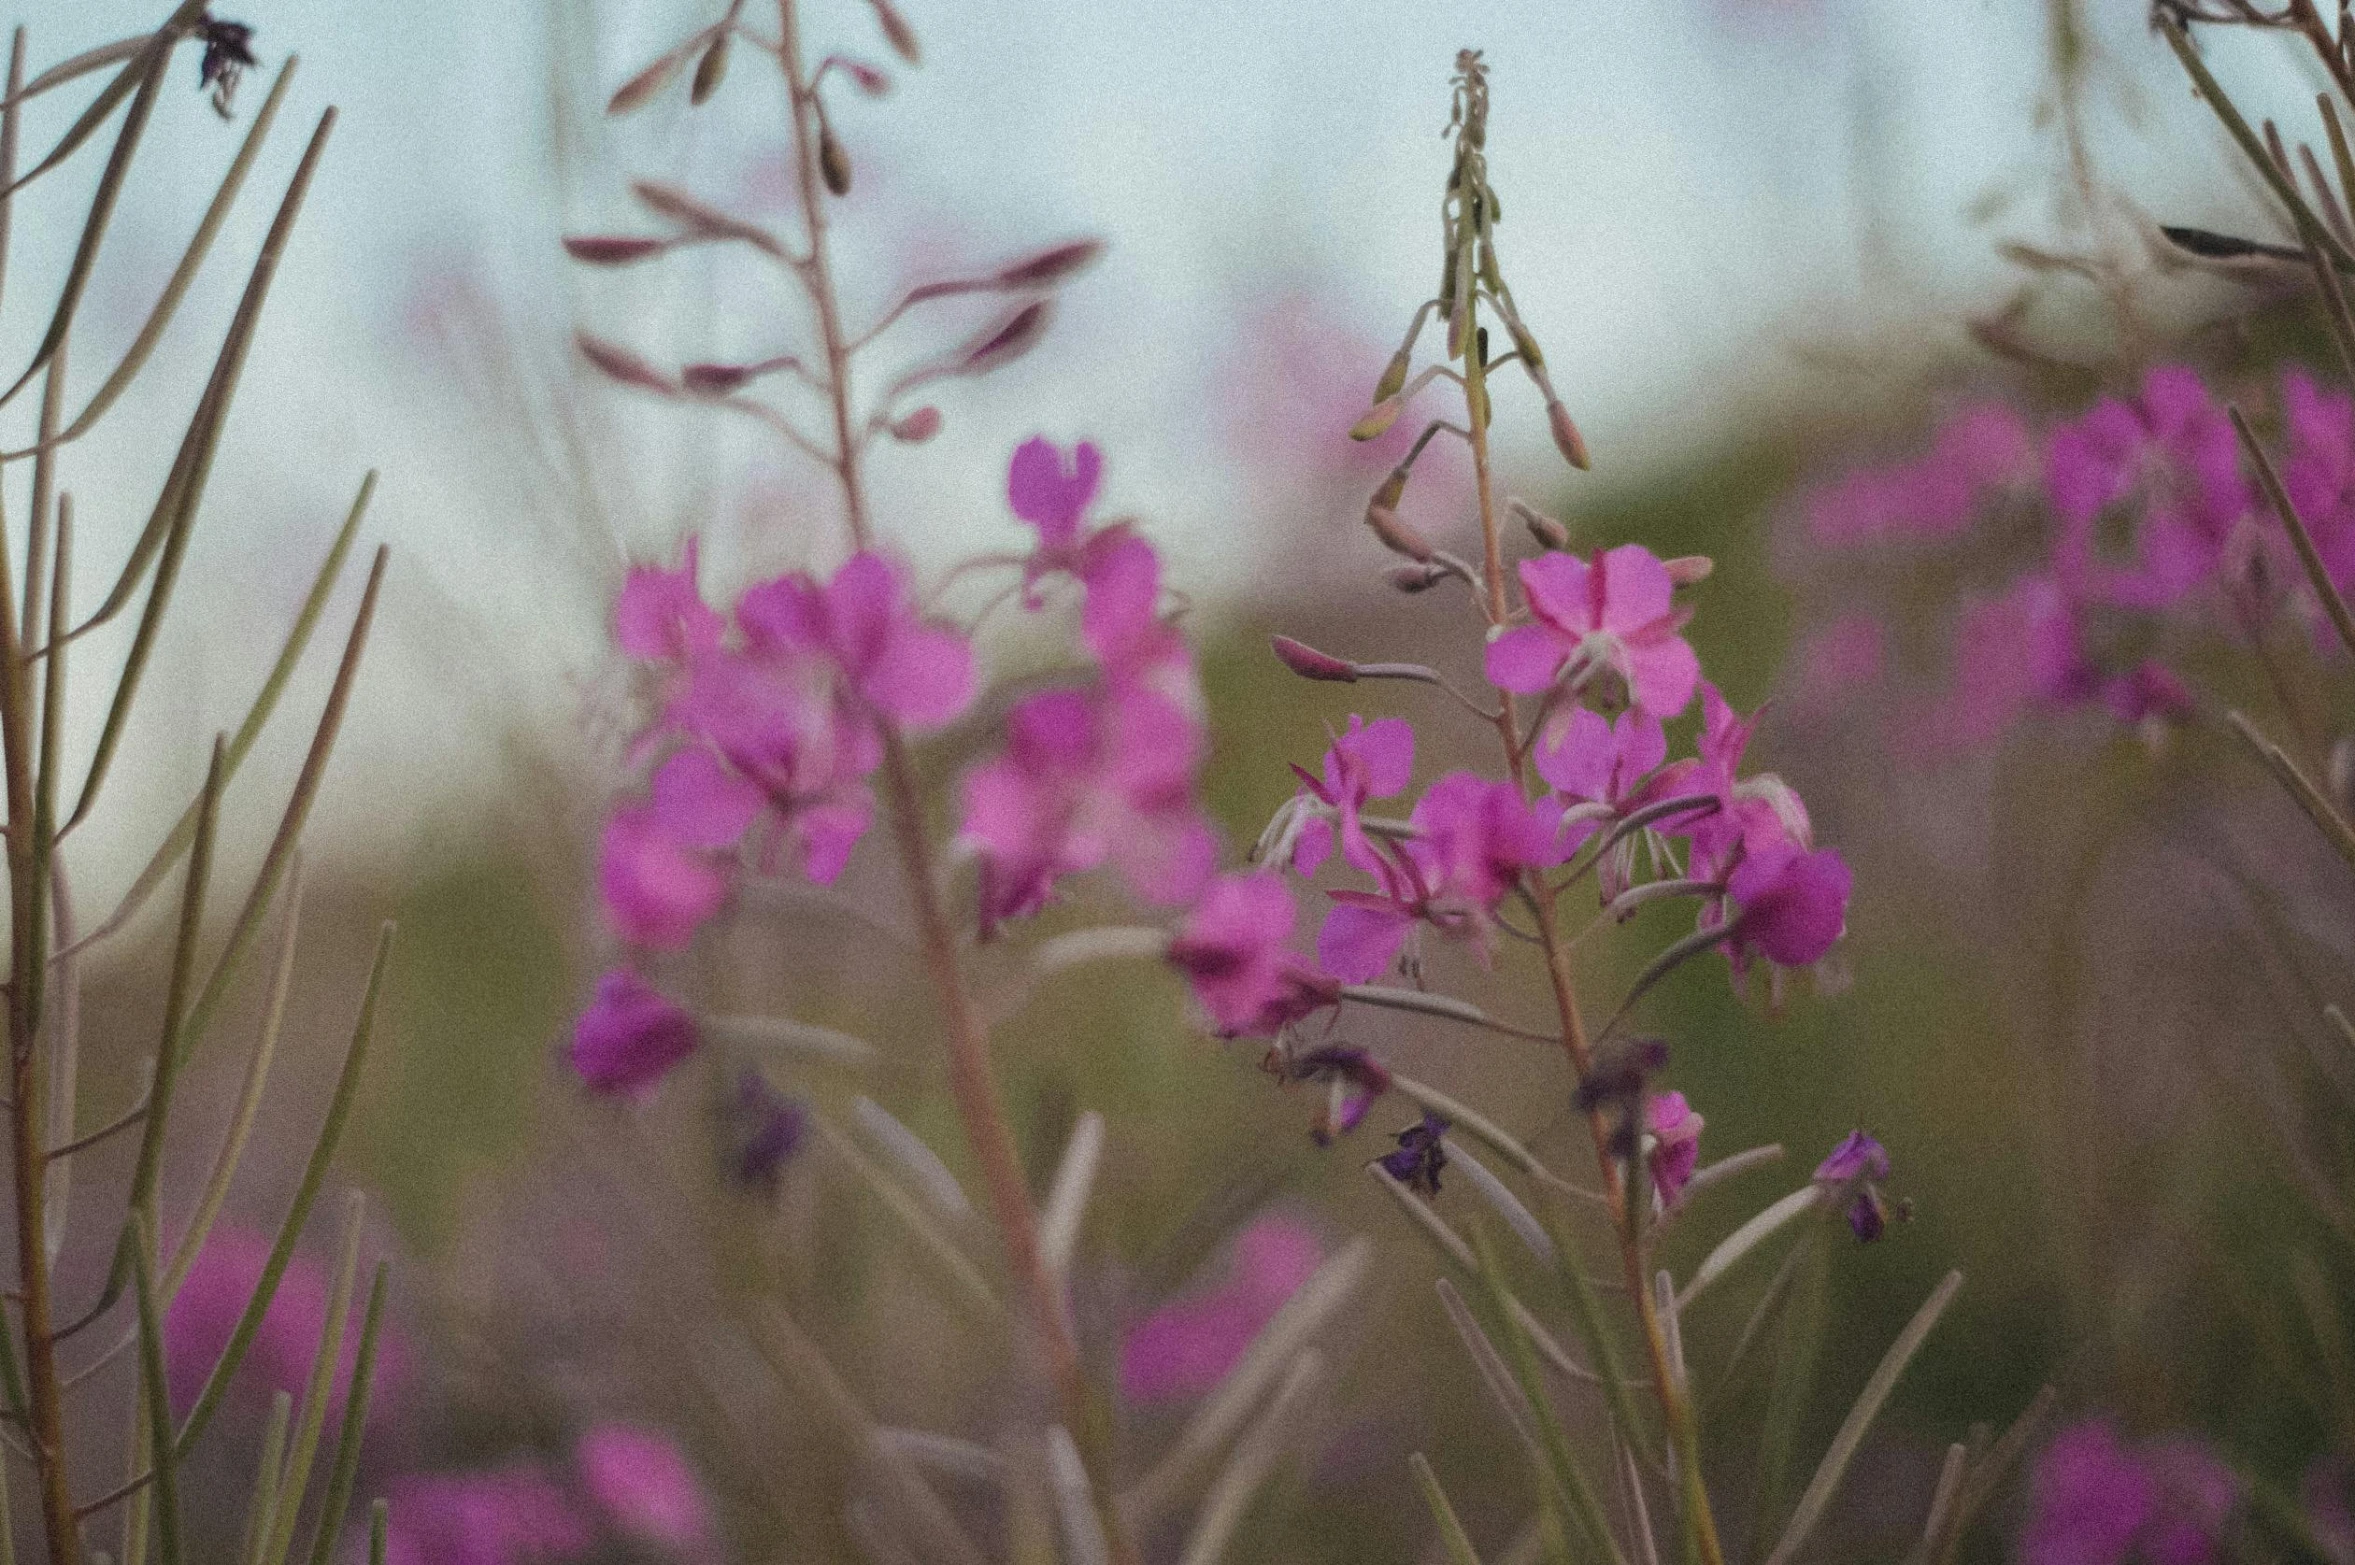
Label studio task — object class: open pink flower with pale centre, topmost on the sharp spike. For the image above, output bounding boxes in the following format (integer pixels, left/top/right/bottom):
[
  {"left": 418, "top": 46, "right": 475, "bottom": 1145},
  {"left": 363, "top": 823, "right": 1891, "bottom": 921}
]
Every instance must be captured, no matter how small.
[{"left": 1488, "top": 544, "right": 1700, "bottom": 718}]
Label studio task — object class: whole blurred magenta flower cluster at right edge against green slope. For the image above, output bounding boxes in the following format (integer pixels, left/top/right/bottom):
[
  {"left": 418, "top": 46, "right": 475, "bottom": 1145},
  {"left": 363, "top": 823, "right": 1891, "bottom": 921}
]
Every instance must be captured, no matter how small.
[{"left": 1802, "top": 365, "right": 2355, "bottom": 748}]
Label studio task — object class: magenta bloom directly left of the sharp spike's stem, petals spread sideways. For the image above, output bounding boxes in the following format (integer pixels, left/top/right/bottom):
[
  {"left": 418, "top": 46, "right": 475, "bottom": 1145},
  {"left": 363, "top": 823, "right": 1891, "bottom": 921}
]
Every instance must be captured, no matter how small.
[{"left": 1316, "top": 772, "right": 1564, "bottom": 984}]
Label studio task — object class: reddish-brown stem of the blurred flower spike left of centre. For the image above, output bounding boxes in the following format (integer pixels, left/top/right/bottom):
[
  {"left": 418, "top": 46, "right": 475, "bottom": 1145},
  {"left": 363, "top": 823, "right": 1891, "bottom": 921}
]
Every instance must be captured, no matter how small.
[{"left": 777, "top": 0, "right": 1137, "bottom": 1565}]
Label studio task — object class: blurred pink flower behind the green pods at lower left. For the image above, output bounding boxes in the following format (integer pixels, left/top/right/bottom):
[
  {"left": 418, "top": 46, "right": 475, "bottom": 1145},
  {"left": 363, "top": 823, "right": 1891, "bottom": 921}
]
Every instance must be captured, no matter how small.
[{"left": 162, "top": 1221, "right": 410, "bottom": 1424}]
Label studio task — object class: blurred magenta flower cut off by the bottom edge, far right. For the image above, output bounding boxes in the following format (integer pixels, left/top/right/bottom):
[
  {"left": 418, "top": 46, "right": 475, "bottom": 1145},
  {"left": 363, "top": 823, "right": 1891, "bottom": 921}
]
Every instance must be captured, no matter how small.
[{"left": 2018, "top": 1419, "right": 2237, "bottom": 1565}]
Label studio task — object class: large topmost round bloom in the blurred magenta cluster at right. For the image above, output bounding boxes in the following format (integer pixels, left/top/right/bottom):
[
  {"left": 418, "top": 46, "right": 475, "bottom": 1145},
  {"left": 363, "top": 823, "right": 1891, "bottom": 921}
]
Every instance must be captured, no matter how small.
[{"left": 2044, "top": 365, "right": 2254, "bottom": 610}]
